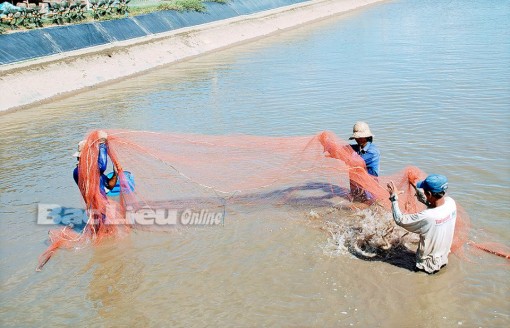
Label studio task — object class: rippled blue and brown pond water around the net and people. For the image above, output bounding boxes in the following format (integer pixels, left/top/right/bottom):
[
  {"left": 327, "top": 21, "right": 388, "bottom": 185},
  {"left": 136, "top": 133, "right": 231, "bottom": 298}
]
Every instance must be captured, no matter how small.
[{"left": 0, "top": 0, "right": 510, "bottom": 327}]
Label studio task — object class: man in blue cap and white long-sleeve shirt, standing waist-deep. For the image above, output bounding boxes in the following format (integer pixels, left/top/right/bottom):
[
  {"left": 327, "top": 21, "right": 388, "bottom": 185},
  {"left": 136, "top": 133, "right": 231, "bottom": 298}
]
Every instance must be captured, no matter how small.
[{"left": 388, "top": 174, "right": 457, "bottom": 273}]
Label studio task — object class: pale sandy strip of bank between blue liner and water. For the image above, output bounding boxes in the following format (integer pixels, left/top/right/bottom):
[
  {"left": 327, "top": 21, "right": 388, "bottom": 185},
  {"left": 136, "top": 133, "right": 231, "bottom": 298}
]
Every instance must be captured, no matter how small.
[{"left": 0, "top": 0, "right": 383, "bottom": 113}]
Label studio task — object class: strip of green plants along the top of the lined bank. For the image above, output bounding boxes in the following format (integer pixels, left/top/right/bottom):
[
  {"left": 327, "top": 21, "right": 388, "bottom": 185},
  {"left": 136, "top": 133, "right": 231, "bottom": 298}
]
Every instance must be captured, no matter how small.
[{"left": 0, "top": 0, "right": 228, "bottom": 34}]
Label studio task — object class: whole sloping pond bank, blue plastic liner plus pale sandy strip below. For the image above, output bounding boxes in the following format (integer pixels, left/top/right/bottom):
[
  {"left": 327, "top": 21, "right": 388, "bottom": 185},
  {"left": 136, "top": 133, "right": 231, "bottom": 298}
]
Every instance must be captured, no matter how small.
[{"left": 0, "top": 0, "right": 382, "bottom": 112}]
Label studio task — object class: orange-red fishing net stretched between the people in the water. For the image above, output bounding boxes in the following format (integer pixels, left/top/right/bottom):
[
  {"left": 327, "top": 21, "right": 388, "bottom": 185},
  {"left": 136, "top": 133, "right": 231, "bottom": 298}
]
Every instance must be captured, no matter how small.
[{"left": 38, "top": 130, "right": 509, "bottom": 270}]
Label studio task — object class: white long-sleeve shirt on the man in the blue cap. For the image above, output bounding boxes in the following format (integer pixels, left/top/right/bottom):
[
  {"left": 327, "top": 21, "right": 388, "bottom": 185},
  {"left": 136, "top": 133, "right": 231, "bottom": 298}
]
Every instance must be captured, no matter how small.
[{"left": 391, "top": 197, "right": 457, "bottom": 273}]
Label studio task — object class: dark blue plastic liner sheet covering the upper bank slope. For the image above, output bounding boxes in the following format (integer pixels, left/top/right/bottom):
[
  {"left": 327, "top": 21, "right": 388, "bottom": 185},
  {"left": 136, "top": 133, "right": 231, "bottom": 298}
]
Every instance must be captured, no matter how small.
[{"left": 0, "top": 0, "right": 308, "bottom": 65}]
